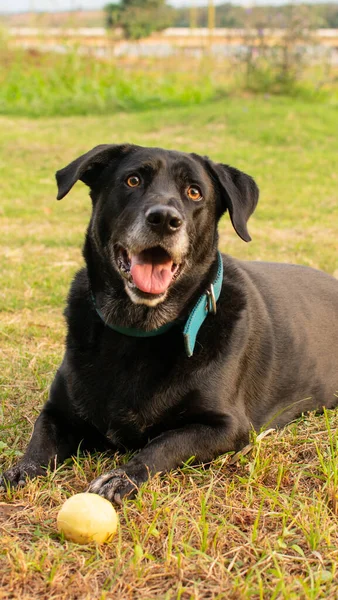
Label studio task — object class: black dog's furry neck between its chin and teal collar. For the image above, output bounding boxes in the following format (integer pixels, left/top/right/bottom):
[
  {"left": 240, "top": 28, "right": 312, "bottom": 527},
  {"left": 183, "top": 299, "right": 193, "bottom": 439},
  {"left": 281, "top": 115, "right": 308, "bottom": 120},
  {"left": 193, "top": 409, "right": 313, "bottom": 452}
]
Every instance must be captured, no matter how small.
[{"left": 83, "top": 237, "right": 217, "bottom": 331}]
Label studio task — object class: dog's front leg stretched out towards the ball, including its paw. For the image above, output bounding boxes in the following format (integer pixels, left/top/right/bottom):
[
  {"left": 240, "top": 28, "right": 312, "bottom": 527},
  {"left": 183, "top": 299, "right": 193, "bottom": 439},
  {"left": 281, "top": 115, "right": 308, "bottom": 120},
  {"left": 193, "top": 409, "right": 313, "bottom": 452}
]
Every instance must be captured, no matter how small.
[{"left": 88, "top": 415, "right": 249, "bottom": 504}]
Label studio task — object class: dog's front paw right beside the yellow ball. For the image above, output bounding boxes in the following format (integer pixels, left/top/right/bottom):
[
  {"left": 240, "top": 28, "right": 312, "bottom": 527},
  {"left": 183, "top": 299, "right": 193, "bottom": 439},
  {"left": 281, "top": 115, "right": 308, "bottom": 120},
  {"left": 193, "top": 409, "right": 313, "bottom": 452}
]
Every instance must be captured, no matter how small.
[{"left": 87, "top": 469, "right": 147, "bottom": 505}]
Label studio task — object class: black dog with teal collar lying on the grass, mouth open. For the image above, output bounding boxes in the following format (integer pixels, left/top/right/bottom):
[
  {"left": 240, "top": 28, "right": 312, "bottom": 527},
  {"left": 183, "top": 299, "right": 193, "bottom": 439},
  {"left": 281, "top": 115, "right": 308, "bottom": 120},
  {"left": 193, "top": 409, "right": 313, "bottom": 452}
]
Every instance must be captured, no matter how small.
[{"left": 2, "top": 145, "right": 338, "bottom": 503}]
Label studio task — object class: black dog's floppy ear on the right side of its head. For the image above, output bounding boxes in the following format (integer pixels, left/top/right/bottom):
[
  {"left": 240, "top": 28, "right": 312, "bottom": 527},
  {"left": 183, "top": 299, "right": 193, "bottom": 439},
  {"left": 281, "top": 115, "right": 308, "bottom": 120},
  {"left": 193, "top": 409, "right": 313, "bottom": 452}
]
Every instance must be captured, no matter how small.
[{"left": 208, "top": 161, "right": 259, "bottom": 242}]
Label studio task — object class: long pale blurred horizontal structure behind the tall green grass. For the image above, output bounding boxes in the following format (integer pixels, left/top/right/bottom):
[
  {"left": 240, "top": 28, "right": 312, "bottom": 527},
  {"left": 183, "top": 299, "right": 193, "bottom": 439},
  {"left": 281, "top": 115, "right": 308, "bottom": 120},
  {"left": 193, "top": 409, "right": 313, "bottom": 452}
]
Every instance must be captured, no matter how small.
[{"left": 9, "top": 27, "right": 338, "bottom": 64}]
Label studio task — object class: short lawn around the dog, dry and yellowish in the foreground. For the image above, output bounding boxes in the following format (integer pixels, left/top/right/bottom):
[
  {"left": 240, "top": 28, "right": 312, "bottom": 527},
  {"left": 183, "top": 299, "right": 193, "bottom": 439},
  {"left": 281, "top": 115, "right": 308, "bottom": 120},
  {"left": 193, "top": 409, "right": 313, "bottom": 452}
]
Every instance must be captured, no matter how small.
[{"left": 0, "top": 98, "right": 338, "bottom": 600}]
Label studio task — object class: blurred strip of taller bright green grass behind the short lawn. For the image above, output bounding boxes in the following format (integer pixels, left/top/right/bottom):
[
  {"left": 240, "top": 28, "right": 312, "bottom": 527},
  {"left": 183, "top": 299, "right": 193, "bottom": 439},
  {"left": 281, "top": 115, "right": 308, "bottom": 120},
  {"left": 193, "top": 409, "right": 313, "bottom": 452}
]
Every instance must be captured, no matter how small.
[{"left": 0, "top": 42, "right": 338, "bottom": 117}]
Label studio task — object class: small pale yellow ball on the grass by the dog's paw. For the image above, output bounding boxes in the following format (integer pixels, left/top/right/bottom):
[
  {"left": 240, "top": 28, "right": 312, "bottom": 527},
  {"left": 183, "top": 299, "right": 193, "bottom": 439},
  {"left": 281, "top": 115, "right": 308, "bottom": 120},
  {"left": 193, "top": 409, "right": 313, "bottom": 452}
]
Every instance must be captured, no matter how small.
[{"left": 57, "top": 493, "right": 118, "bottom": 544}]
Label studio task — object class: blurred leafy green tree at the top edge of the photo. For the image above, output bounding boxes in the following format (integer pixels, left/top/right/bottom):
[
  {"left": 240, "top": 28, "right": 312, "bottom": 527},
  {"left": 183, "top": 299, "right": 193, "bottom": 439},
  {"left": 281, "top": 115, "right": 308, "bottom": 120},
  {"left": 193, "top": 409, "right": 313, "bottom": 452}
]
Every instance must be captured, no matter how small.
[{"left": 105, "top": 0, "right": 174, "bottom": 40}]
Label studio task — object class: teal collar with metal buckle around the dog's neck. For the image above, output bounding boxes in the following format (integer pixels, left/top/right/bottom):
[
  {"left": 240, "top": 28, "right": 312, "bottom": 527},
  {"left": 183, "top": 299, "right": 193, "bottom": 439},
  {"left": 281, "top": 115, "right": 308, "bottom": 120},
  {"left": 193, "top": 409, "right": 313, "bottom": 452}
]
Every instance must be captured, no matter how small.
[{"left": 92, "top": 252, "right": 223, "bottom": 357}]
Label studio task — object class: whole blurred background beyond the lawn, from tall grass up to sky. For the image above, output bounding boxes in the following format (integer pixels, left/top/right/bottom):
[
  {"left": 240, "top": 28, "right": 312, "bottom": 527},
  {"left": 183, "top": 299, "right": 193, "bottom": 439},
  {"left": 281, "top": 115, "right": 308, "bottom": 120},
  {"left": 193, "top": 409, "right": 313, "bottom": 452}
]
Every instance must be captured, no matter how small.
[{"left": 0, "top": 0, "right": 338, "bottom": 116}]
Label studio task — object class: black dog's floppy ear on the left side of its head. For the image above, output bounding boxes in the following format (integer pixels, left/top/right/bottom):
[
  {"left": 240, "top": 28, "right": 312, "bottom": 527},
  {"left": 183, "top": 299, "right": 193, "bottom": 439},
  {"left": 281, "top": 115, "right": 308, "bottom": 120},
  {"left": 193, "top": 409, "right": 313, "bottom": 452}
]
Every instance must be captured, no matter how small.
[{"left": 55, "top": 144, "right": 130, "bottom": 200}]
